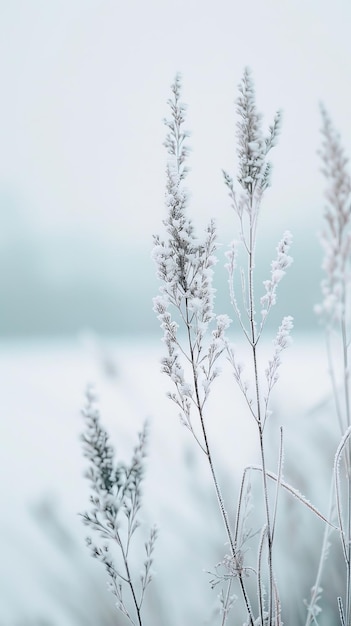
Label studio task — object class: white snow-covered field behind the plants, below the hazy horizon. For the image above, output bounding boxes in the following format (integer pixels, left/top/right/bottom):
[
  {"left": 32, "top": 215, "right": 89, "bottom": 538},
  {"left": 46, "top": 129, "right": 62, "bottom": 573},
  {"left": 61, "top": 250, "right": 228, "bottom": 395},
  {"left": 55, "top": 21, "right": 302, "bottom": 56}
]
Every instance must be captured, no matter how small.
[{"left": 0, "top": 335, "right": 338, "bottom": 626}]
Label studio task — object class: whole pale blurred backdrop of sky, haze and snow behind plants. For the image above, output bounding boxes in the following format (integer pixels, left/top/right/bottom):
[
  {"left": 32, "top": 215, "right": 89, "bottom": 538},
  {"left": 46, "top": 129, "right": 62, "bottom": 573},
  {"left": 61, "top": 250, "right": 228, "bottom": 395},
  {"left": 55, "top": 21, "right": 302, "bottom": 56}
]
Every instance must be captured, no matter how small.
[{"left": 0, "top": 0, "right": 351, "bottom": 626}]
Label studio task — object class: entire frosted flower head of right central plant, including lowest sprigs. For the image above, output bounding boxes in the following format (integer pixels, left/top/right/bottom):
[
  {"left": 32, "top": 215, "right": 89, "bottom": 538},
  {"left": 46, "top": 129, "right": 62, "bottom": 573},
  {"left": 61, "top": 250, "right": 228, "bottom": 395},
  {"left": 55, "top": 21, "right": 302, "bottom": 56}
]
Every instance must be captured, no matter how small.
[{"left": 224, "top": 69, "right": 293, "bottom": 438}]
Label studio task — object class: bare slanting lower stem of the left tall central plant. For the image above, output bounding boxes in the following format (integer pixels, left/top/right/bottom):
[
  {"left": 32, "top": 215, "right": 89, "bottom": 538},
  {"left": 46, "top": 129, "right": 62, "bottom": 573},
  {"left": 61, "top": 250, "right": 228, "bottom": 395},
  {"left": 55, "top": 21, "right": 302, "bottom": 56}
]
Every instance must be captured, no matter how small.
[{"left": 185, "top": 298, "right": 254, "bottom": 626}]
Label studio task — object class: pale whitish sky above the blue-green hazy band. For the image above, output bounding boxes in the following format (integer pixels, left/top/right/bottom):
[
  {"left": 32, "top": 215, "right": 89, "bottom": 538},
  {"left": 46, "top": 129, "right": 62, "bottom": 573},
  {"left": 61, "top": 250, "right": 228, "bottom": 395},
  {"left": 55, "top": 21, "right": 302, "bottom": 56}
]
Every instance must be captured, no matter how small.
[{"left": 0, "top": 0, "right": 351, "bottom": 334}]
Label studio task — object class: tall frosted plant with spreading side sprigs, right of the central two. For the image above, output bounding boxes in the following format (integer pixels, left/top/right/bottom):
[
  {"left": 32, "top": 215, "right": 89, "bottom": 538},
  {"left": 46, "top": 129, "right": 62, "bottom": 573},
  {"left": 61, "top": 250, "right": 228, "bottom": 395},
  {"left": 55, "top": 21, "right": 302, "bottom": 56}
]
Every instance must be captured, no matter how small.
[{"left": 224, "top": 69, "right": 293, "bottom": 626}]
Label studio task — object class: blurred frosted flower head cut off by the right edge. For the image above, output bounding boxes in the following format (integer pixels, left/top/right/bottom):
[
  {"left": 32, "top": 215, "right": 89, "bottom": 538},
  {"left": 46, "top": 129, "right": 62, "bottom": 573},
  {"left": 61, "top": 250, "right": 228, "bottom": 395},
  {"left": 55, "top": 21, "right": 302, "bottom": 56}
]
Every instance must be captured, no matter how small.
[{"left": 316, "top": 108, "right": 351, "bottom": 326}]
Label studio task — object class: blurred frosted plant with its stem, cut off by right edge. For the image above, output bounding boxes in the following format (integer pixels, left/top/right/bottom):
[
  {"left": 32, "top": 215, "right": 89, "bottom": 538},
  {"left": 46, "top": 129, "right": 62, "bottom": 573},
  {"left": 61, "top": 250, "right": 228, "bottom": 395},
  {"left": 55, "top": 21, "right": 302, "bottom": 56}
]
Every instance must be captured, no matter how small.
[{"left": 306, "top": 107, "right": 351, "bottom": 626}]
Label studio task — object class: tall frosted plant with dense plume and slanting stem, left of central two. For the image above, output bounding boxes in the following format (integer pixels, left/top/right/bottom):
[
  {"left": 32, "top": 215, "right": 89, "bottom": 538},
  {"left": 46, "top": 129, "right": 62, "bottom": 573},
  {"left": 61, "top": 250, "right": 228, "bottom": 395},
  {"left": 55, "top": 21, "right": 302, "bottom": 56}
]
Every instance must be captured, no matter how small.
[{"left": 153, "top": 76, "right": 253, "bottom": 623}]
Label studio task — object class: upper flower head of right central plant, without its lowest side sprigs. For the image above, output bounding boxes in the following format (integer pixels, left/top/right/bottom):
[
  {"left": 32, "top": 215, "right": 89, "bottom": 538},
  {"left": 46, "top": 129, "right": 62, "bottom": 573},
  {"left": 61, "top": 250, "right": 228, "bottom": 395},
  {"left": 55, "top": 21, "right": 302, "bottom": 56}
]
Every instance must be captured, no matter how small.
[{"left": 223, "top": 69, "right": 292, "bottom": 356}]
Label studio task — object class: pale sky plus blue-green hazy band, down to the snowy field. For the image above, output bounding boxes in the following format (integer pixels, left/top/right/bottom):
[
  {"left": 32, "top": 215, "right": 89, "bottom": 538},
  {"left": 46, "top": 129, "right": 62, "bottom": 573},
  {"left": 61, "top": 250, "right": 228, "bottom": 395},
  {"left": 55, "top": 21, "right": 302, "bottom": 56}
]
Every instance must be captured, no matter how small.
[{"left": 0, "top": 0, "right": 351, "bottom": 337}]
